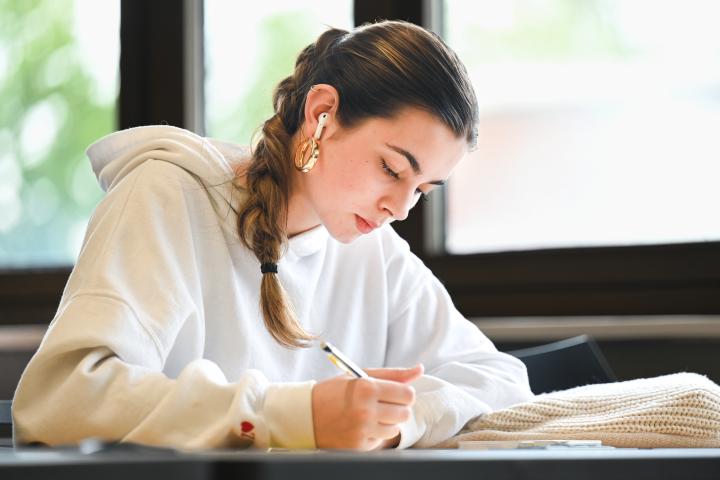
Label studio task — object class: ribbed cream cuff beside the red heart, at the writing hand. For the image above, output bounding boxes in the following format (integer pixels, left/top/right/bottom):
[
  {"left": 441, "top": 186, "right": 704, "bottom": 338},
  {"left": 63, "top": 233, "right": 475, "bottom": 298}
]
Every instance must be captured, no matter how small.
[{"left": 263, "top": 381, "right": 316, "bottom": 449}]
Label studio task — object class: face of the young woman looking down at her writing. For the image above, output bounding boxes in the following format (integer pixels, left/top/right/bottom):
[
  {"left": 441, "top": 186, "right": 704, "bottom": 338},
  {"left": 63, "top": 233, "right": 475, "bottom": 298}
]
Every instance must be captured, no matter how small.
[{"left": 290, "top": 108, "right": 468, "bottom": 243}]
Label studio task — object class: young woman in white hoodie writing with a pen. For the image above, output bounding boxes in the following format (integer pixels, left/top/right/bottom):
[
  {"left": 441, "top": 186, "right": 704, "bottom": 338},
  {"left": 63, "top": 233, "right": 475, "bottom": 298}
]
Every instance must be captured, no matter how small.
[{"left": 13, "top": 22, "right": 531, "bottom": 450}]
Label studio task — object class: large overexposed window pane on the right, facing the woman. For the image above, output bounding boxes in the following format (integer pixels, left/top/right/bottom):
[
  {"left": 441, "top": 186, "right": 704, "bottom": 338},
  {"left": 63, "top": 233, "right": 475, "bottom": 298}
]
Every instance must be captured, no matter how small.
[{"left": 444, "top": 0, "right": 720, "bottom": 254}]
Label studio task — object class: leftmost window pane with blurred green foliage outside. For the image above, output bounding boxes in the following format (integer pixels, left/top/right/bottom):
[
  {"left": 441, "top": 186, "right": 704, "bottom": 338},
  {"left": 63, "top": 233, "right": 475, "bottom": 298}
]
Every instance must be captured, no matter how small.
[{"left": 0, "top": 0, "right": 120, "bottom": 269}]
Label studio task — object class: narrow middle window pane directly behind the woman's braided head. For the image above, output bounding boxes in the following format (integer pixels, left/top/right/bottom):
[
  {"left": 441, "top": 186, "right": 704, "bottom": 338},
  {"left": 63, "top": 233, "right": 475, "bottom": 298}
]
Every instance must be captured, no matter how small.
[{"left": 205, "top": 0, "right": 353, "bottom": 144}]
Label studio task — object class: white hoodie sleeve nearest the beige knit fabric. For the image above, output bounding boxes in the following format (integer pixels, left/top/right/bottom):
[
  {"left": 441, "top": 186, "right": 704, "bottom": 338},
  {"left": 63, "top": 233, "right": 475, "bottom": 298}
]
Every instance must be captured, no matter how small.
[{"left": 386, "top": 232, "right": 533, "bottom": 448}]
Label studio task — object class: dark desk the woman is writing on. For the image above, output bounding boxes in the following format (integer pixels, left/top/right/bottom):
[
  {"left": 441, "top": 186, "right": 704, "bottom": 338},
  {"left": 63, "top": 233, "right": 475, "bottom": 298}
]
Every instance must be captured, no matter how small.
[{"left": 0, "top": 449, "right": 720, "bottom": 480}]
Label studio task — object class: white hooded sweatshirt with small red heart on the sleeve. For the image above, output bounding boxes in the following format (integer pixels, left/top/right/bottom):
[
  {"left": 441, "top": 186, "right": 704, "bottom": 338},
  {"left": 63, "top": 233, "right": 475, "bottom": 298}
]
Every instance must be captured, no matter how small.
[{"left": 13, "top": 126, "right": 532, "bottom": 449}]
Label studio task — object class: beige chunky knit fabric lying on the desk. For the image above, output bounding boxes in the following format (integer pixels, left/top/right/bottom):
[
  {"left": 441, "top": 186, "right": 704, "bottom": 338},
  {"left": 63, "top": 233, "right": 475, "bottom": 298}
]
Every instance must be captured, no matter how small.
[{"left": 435, "top": 373, "right": 720, "bottom": 448}]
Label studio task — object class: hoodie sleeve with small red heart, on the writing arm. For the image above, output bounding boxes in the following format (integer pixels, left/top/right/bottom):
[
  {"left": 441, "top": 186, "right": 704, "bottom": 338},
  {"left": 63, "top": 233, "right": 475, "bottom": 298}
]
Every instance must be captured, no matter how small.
[{"left": 13, "top": 160, "right": 315, "bottom": 449}]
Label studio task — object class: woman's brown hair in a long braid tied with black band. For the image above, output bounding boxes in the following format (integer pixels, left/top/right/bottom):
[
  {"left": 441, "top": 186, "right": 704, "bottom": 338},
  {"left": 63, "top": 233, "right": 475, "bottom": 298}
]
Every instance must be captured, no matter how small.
[{"left": 238, "top": 21, "right": 478, "bottom": 348}]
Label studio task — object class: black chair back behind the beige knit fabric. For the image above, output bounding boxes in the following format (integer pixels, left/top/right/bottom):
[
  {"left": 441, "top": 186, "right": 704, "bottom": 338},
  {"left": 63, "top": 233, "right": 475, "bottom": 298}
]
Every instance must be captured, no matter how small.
[{"left": 507, "top": 335, "right": 617, "bottom": 394}]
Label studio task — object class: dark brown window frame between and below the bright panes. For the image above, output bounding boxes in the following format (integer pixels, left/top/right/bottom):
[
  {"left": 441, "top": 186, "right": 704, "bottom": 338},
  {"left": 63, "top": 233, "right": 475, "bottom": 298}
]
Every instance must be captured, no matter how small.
[{"left": 0, "top": 0, "right": 720, "bottom": 325}]
